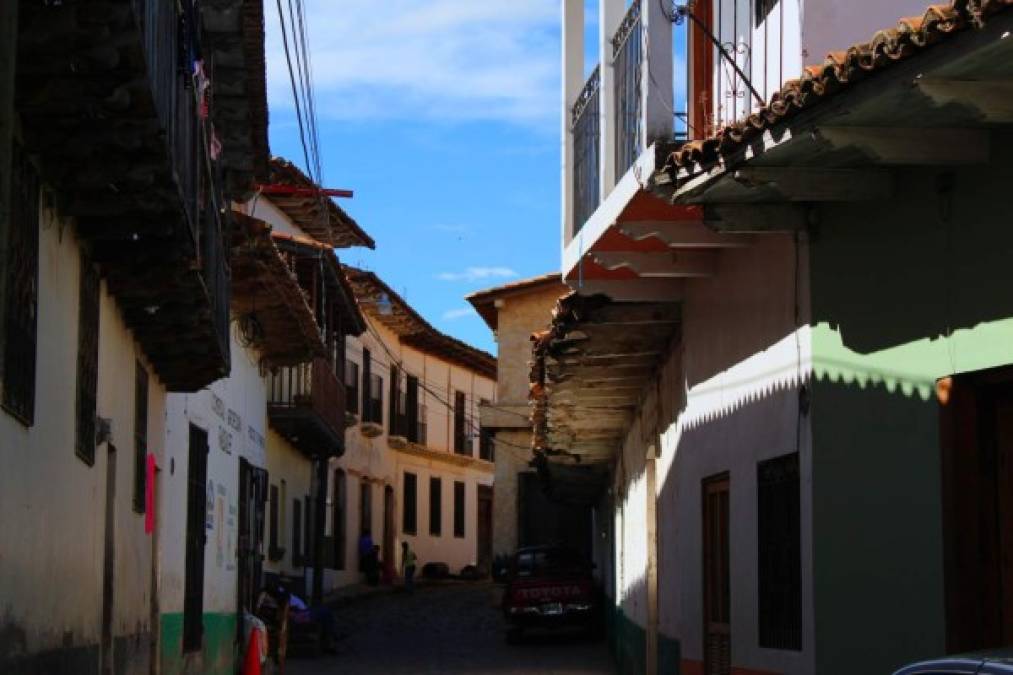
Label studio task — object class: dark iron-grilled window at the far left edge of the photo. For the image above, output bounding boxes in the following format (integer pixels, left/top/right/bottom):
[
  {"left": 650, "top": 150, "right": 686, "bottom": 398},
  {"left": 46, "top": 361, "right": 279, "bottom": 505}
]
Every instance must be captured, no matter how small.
[{"left": 0, "top": 143, "right": 38, "bottom": 427}]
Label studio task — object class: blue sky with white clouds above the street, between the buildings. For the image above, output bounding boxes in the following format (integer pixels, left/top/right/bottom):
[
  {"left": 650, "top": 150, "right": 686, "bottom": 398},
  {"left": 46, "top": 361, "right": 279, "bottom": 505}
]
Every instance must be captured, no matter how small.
[{"left": 265, "top": 0, "right": 688, "bottom": 353}]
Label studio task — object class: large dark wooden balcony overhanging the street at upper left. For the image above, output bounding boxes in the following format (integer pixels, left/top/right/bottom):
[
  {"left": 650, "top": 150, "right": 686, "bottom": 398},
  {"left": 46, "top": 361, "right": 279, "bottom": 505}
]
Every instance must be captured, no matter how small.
[{"left": 15, "top": 0, "right": 265, "bottom": 391}]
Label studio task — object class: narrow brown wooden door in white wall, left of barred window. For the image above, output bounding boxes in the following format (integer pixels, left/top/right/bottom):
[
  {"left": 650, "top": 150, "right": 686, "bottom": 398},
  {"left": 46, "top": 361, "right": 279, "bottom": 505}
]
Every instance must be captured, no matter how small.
[{"left": 703, "top": 473, "right": 731, "bottom": 675}]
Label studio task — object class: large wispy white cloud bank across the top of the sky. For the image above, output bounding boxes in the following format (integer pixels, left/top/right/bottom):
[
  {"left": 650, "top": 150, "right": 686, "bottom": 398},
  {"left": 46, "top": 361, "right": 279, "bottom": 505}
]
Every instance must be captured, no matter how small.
[{"left": 266, "top": 0, "right": 560, "bottom": 130}]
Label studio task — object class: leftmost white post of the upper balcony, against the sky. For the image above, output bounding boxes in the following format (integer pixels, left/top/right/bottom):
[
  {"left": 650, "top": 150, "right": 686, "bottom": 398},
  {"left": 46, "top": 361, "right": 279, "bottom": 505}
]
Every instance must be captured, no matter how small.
[{"left": 560, "top": 0, "right": 583, "bottom": 248}]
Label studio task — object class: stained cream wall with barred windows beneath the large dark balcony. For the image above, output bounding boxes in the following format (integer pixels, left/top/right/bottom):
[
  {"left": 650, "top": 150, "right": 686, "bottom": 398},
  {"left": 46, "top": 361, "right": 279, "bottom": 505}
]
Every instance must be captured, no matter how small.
[{"left": 0, "top": 207, "right": 165, "bottom": 675}]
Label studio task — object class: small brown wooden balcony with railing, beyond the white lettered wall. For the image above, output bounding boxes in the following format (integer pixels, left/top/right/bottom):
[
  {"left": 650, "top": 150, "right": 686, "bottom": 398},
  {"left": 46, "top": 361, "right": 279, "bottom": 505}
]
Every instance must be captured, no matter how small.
[{"left": 267, "top": 358, "right": 344, "bottom": 457}]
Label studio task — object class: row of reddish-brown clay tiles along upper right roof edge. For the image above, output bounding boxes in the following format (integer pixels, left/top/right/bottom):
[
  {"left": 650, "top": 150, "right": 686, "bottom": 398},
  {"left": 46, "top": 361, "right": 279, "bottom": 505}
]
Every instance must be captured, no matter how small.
[{"left": 664, "top": 0, "right": 1013, "bottom": 172}]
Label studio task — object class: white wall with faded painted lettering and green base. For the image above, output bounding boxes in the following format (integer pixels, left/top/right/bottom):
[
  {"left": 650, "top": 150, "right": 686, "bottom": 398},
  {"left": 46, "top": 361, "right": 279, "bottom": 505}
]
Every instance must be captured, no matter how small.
[{"left": 157, "top": 327, "right": 266, "bottom": 674}]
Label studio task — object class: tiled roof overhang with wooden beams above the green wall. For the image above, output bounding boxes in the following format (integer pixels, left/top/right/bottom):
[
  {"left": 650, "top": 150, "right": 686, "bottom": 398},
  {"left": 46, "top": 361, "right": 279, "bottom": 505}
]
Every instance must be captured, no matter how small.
[{"left": 649, "top": 0, "right": 1013, "bottom": 210}]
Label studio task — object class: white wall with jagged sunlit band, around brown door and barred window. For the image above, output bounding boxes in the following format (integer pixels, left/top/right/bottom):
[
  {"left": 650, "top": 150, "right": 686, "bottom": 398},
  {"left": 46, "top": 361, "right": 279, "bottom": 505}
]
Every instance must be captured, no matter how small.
[{"left": 597, "top": 235, "right": 814, "bottom": 673}]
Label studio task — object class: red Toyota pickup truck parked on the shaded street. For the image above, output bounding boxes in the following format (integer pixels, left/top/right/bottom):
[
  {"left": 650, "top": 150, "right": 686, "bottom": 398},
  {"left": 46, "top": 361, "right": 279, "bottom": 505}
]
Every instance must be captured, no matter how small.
[{"left": 502, "top": 546, "right": 602, "bottom": 643}]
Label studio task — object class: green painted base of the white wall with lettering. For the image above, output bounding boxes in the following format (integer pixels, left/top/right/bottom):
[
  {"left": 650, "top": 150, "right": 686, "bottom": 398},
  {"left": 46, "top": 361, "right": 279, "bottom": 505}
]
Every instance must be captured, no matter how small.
[{"left": 161, "top": 612, "right": 236, "bottom": 675}]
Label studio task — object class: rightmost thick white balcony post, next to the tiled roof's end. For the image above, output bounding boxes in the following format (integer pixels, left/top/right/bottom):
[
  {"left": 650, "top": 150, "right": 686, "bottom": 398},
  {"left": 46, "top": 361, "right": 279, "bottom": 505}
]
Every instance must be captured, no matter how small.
[{"left": 640, "top": 0, "right": 674, "bottom": 150}]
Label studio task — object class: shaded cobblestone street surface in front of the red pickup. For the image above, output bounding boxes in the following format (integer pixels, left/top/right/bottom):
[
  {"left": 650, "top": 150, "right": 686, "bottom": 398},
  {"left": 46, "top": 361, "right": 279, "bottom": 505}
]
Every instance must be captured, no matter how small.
[{"left": 286, "top": 583, "right": 615, "bottom": 675}]
